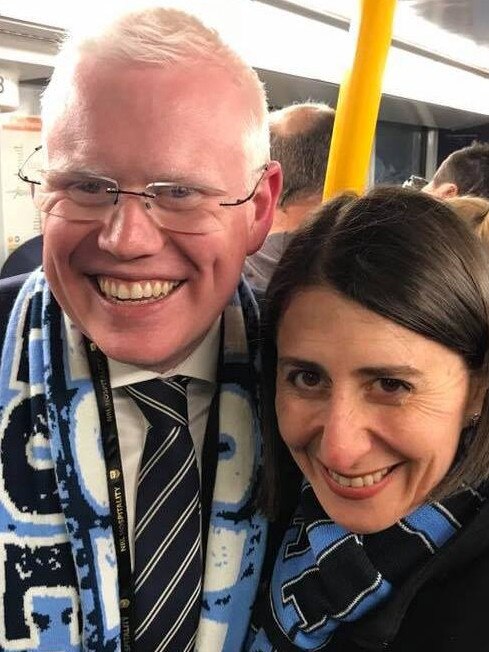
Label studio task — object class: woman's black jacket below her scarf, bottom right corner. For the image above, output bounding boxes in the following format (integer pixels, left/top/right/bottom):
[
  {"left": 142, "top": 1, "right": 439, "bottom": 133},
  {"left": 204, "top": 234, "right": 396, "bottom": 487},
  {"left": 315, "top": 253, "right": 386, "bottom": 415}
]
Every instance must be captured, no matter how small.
[{"left": 331, "top": 496, "right": 489, "bottom": 652}]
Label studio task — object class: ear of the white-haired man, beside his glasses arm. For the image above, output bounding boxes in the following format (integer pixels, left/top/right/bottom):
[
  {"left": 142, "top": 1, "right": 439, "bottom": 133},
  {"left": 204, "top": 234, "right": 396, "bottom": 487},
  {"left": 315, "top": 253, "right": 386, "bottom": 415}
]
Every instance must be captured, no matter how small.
[{"left": 247, "top": 161, "right": 282, "bottom": 255}]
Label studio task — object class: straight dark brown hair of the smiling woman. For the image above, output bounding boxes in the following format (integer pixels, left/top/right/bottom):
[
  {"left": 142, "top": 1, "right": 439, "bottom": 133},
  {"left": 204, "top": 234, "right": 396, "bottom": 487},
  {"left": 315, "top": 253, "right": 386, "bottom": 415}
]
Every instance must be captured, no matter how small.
[{"left": 260, "top": 187, "right": 489, "bottom": 517}]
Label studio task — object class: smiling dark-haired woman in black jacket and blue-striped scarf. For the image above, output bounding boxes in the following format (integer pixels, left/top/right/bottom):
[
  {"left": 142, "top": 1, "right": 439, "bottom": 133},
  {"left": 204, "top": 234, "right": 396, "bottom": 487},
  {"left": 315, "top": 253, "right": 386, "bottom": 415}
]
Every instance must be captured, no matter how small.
[{"left": 248, "top": 188, "right": 489, "bottom": 652}]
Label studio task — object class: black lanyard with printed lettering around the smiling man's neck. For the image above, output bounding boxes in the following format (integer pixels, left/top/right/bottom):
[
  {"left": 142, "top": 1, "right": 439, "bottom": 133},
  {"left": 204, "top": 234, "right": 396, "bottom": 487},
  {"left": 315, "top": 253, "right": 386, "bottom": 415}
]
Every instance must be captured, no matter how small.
[{"left": 85, "top": 338, "right": 223, "bottom": 652}]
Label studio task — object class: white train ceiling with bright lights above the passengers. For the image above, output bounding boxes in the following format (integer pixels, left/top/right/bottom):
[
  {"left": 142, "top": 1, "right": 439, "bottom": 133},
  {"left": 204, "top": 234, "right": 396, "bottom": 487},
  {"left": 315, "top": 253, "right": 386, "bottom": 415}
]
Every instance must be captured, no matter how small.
[{"left": 0, "top": 0, "right": 489, "bottom": 126}]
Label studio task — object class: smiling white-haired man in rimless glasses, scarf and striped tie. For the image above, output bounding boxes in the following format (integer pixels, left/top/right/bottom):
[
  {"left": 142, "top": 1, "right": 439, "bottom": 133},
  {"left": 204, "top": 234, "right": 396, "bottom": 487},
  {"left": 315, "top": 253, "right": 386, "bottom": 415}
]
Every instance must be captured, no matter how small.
[{"left": 0, "top": 8, "right": 281, "bottom": 652}]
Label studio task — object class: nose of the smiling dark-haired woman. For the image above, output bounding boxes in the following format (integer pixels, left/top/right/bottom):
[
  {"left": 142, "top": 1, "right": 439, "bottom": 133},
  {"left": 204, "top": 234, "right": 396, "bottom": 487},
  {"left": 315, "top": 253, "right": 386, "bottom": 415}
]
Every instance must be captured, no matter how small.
[{"left": 320, "top": 391, "right": 375, "bottom": 473}]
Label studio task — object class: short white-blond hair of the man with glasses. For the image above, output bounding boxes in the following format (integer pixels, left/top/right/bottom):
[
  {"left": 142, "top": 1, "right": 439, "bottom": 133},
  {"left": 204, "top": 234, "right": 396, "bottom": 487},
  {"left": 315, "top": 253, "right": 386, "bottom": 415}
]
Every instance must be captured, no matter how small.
[{"left": 41, "top": 7, "right": 270, "bottom": 172}]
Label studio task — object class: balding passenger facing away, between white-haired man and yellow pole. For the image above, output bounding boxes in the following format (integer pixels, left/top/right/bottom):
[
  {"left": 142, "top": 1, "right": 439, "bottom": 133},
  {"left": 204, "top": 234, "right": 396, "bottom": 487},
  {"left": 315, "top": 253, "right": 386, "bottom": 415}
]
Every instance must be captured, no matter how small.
[{"left": 244, "top": 102, "right": 335, "bottom": 293}]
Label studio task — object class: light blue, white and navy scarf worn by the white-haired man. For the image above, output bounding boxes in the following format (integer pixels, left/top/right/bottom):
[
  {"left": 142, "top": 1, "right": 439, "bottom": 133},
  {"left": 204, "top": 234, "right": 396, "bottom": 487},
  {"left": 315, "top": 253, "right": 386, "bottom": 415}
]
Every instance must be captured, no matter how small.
[{"left": 0, "top": 271, "right": 266, "bottom": 652}]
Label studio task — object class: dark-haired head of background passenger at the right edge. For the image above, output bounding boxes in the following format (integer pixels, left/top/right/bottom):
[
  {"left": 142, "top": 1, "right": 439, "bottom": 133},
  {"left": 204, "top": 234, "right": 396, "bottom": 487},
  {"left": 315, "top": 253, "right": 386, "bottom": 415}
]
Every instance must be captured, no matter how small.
[{"left": 423, "top": 143, "right": 489, "bottom": 199}]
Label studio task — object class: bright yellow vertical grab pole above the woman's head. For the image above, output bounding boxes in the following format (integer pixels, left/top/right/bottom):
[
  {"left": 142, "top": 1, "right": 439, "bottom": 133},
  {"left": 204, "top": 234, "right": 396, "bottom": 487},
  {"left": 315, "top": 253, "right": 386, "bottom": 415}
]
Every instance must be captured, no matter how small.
[{"left": 323, "top": 0, "right": 396, "bottom": 200}]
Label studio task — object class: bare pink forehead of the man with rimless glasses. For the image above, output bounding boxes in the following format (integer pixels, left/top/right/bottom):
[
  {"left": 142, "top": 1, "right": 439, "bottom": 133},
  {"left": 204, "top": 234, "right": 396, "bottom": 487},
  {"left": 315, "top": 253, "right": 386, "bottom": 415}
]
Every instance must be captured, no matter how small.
[{"left": 48, "top": 59, "right": 253, "bottom": 181}]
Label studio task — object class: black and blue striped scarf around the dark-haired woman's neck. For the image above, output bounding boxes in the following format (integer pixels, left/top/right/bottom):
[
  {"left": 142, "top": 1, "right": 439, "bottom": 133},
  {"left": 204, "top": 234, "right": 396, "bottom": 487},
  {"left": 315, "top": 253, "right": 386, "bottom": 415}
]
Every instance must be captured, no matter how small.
[{"left": 246, "top": 483, "right": 486, "bottom": 652}]
